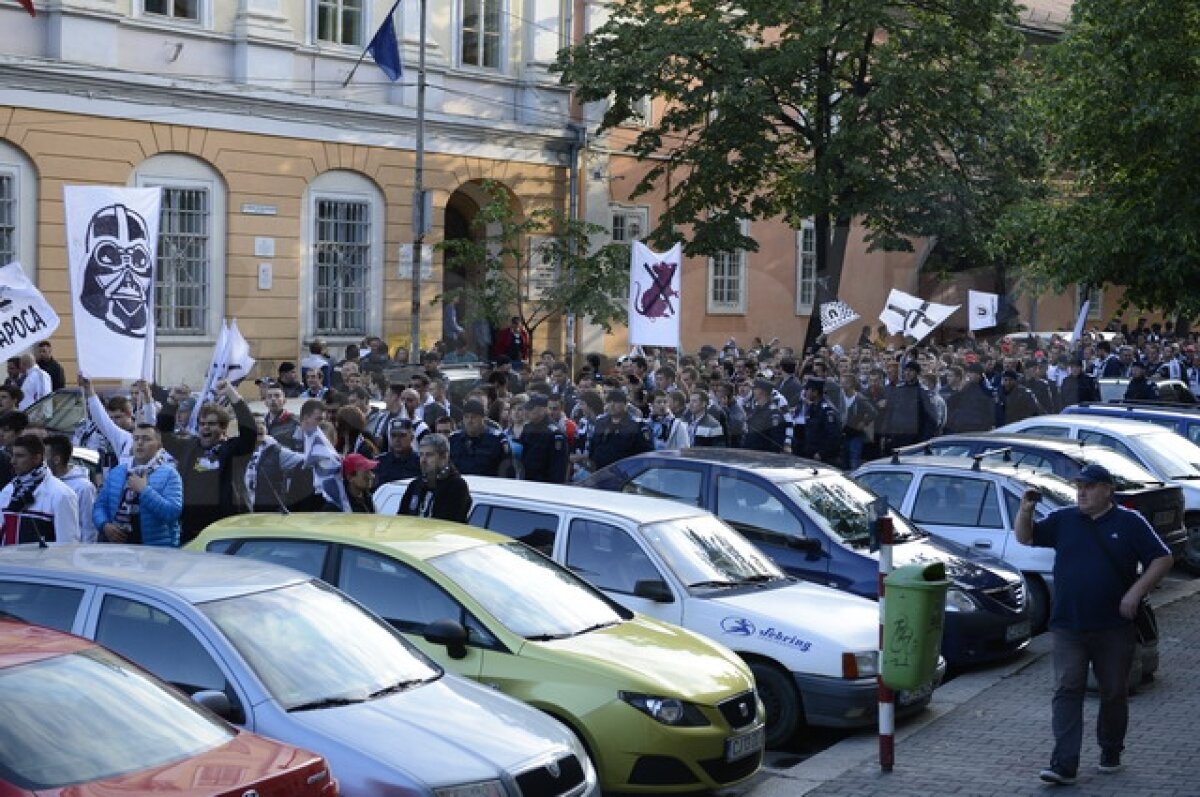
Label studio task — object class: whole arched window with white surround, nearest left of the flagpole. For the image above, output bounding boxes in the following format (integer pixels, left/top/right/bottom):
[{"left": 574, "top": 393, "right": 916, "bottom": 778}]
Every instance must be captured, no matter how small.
[{"left": 301, "top": 170, "right": 384, "bottom": 340}]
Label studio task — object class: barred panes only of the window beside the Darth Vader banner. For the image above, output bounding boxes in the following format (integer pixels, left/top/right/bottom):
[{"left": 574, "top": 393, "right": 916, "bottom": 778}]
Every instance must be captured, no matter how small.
[{"left": 155, "top": 186, "right": 212, "bottom": 335}]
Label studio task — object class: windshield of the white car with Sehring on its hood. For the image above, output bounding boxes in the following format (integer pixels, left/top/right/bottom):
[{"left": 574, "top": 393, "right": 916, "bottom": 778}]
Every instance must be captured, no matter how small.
[{"left": 642, "top": 515, "right": 786, "bottom": 587}]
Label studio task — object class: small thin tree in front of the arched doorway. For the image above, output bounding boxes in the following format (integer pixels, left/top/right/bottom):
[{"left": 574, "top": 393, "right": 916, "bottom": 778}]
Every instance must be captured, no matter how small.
[{"left": 433, "top": 181, "right": 630, "bottom": 343}]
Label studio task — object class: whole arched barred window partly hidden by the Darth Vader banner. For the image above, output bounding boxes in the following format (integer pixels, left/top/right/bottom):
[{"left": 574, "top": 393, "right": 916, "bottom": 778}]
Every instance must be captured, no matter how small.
[{"left": 133, "top": 155, "right": 226, "bottom": 338}]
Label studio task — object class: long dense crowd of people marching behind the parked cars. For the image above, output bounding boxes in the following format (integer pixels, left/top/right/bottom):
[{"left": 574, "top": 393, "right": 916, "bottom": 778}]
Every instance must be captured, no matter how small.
[{"left": 0, "top": 314, "right": 1200, "bottom": 546}]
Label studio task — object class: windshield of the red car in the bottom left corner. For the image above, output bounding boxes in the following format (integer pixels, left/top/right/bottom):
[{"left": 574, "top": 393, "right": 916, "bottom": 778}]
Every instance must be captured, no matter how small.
[{"left": 0, "top": 648, "right": 235, "bottom": 791}]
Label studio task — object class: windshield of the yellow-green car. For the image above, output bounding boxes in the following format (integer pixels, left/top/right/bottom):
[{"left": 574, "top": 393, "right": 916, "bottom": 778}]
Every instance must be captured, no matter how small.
[{"left": 430, "top": 543, "right": 624, "bottom": 641}]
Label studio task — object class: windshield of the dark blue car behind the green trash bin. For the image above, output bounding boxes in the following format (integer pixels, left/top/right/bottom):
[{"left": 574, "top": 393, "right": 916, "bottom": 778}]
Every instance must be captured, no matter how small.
[{"left": 779, "top": 473, "right": 924, "bottom": 547}]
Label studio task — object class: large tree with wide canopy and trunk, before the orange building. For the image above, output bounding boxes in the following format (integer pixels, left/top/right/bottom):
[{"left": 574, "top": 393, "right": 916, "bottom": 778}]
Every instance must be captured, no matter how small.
[{"left": 557, "top": 0, "right": 1037, "bottom": 338}]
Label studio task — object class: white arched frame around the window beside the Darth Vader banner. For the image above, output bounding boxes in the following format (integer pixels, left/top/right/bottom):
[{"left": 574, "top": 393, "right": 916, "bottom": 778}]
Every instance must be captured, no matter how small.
[{"left": 131, "top": 154, "right": 228, "bottom": 344}]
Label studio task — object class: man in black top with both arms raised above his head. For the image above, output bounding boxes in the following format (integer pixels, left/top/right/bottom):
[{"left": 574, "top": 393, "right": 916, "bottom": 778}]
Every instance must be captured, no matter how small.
[{"left": 158, "top": 379, "right": 258, "bottom": 544}]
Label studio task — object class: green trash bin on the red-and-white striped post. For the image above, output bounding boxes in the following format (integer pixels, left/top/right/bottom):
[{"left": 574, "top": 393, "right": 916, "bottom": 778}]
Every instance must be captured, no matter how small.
[{"left": 880, "top": 562, "right": 950, "bottom": 689}]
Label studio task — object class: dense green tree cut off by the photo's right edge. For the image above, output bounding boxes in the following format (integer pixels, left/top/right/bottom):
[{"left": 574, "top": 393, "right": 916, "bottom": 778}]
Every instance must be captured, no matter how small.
[{"left": 1007, "top": 0, "right": 1200, "bottom": 318}]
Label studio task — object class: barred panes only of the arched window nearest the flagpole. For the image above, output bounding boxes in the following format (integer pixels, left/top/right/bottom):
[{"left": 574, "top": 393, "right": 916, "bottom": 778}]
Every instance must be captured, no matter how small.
[{"left": 313, "top": 198, "right": 371, "bottom": 336}]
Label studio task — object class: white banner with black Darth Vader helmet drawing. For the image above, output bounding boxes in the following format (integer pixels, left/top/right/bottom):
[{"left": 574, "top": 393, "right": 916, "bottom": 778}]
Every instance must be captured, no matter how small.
[{"left": 64, "top": 186, "right": 162, "bottom": 379}]
